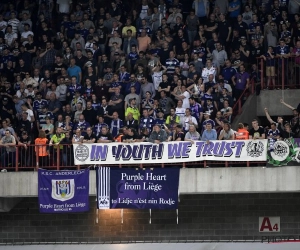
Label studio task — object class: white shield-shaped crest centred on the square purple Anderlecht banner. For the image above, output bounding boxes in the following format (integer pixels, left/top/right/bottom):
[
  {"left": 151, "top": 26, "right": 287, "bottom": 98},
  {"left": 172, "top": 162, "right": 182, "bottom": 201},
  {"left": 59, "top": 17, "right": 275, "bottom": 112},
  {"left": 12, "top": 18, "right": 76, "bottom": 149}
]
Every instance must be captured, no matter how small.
[{"left": 51, "top": 179, "right": 75, "bottom": 201}]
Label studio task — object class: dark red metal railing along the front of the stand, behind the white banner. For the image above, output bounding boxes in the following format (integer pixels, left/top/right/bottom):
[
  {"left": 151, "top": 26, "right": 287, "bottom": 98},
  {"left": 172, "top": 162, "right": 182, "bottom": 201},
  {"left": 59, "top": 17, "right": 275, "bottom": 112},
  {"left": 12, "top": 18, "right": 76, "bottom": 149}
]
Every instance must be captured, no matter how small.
[{"left": 0, "top": 145, "right": 266, "bottom": 172}]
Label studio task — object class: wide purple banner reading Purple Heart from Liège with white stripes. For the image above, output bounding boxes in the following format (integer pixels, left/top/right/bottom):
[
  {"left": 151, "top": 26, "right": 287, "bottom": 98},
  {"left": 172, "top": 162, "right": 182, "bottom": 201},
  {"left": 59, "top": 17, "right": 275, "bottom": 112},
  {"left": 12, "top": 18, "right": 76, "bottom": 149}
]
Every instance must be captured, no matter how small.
[{"left": 97, "top": 167, "right": 179, "bottom": 209}]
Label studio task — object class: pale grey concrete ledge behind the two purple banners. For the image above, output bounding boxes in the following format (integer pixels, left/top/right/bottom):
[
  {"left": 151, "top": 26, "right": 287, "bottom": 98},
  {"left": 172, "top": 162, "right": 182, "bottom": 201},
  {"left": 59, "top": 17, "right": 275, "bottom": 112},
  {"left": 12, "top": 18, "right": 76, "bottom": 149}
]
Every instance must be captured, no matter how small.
[{"left": 0, "top": 167, "right": 300, "bottom": 198}]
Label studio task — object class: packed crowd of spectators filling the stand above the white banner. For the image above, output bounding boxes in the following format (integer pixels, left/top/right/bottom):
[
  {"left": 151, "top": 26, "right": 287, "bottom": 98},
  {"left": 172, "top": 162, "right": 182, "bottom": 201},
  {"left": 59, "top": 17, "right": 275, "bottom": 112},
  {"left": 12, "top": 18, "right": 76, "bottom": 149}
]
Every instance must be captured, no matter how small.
[{"left": 0, "top": 0, "right": 300, "bottom": 168}]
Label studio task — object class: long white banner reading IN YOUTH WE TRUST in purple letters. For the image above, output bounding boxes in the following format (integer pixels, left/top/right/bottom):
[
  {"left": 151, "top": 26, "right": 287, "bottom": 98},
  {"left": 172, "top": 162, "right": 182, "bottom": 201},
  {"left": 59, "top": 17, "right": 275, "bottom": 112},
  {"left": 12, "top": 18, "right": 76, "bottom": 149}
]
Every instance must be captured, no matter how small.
[{"left": 74, "top": 140, "right": 267, "bottom": 165}]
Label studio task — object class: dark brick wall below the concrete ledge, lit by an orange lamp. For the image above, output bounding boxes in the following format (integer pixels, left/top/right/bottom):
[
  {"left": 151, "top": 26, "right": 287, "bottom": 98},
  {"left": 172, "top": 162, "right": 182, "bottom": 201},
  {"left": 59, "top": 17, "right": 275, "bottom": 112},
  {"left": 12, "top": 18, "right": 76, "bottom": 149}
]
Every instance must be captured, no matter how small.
[{"left": 0, "top": 193, "right": 300, "bottom": 244}]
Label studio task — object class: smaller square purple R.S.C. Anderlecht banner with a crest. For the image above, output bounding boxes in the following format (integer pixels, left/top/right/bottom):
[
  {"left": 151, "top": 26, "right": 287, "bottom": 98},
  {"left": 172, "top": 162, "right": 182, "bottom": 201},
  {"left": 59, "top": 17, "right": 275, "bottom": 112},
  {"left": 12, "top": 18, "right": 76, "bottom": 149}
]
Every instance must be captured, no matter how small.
[{"left": 38, "top": 169, "right": 90, "bottom": 213}]
